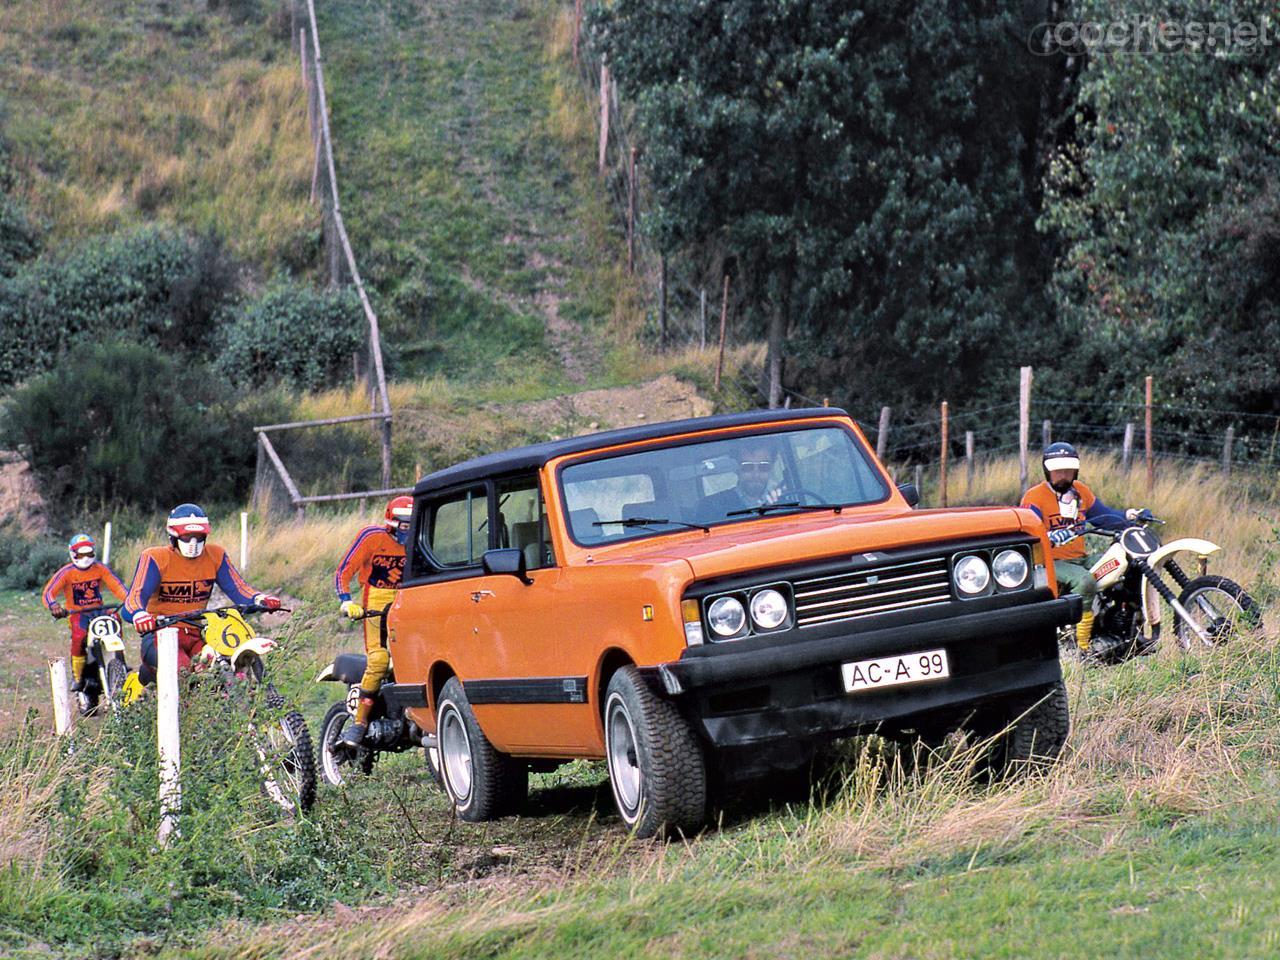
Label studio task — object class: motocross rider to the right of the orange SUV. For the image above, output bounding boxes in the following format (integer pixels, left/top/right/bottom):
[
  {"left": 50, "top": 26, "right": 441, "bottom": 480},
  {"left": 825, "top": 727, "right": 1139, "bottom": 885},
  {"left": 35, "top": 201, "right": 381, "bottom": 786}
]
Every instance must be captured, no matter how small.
[{"left": 1021, "top": 442, "right": 1139, "bottom": 655}]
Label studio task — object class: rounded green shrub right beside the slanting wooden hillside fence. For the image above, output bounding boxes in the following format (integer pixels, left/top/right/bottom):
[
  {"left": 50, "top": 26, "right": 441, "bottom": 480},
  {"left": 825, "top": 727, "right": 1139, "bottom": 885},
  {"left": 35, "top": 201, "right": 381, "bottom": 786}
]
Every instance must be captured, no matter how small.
[{"left": 215, "top": 280, "right": 365, "bottom": 390}]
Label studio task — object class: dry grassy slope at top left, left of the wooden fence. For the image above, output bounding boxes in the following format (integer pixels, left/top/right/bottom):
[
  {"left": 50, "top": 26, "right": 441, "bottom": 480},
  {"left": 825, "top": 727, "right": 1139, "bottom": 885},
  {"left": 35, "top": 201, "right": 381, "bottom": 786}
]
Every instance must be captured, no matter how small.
[{"left": 0, "top": 0, "right": 319, "bottom": 270}]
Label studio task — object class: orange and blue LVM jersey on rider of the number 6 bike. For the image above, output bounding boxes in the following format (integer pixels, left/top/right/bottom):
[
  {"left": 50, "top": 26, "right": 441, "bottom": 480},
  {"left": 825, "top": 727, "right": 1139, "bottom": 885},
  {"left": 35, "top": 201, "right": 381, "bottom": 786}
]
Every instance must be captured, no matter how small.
[{"left": 123, "top": 543, "right": 259, "bottom": 622}]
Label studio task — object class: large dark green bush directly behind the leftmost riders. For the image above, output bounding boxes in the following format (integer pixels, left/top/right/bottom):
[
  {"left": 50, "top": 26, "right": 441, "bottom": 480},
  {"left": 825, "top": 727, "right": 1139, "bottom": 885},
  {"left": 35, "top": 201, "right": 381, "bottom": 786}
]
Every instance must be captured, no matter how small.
[{"left": 0, "top": 340, "right": 255, "bottom": 509}]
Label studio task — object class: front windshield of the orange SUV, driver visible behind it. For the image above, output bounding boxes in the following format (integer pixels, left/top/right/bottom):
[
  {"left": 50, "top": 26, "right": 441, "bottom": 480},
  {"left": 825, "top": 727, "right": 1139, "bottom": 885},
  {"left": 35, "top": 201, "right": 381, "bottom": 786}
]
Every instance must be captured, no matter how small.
[{"left": 561, "top": 426, "right": 888, "bottom": 545}]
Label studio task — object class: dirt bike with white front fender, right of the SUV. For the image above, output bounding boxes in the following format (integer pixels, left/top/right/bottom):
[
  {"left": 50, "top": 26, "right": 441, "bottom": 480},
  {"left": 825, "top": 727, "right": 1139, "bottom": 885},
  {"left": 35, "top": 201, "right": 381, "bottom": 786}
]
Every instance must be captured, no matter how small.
[{"left": 1068, "top": 509, "right": 1262, "bottom": 663}]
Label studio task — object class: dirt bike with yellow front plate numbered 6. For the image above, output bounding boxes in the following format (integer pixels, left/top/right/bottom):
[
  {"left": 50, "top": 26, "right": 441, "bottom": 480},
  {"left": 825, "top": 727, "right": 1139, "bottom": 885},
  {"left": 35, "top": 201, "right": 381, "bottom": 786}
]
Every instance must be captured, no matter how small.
[{"left": 156, "top": 604, "right": 316, "bottom": 814}]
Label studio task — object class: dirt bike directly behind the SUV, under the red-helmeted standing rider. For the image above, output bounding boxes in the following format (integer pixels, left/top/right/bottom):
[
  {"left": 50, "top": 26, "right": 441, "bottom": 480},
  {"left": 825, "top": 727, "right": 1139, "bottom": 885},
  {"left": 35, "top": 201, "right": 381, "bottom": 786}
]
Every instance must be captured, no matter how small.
[{"left": 316, "top": 611, "right": 440, "bottom": 787}]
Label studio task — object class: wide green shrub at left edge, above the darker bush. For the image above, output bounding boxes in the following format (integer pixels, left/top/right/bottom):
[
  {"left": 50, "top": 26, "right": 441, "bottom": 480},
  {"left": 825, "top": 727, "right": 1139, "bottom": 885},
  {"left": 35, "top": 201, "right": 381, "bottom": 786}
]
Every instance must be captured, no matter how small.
[{"left": 0, "top": 227, "right": 236, "bottom": 384}]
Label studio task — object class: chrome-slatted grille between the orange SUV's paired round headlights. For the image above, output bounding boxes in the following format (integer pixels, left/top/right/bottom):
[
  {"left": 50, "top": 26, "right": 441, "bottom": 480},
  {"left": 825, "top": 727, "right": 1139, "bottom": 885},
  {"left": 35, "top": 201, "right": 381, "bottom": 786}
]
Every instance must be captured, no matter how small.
[{"left": 795, "top": 557, "right": 951, "bottom": 627}]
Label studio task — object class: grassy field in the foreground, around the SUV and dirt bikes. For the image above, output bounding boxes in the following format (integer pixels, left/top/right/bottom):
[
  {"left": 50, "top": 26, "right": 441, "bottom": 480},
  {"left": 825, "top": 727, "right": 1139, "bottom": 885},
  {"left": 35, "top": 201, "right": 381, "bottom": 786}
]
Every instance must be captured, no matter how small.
[{"left": 0, "top": 452, "right": 1280, "bottom": 959}]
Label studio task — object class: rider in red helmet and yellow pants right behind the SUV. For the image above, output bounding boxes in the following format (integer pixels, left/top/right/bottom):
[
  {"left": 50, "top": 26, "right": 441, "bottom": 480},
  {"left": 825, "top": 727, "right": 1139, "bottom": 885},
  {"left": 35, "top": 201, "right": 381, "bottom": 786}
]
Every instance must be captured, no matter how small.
[{"left": 334, "top": 497, "right": 413, "bottom": 746}]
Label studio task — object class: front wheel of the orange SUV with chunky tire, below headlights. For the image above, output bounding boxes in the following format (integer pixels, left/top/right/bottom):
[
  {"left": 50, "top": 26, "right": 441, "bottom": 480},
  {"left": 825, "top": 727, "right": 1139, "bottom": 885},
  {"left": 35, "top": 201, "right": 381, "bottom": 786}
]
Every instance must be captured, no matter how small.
[{"left": 604, "top": 667, "right": 707, "bottom": 837}]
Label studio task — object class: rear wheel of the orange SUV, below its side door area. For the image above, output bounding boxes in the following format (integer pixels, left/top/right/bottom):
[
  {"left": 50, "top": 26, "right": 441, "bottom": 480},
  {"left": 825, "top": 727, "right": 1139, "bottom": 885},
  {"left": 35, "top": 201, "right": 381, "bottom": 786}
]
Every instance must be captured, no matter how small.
[{"left": 435, "top": 677, "right": 529, "bottom": 823}]
